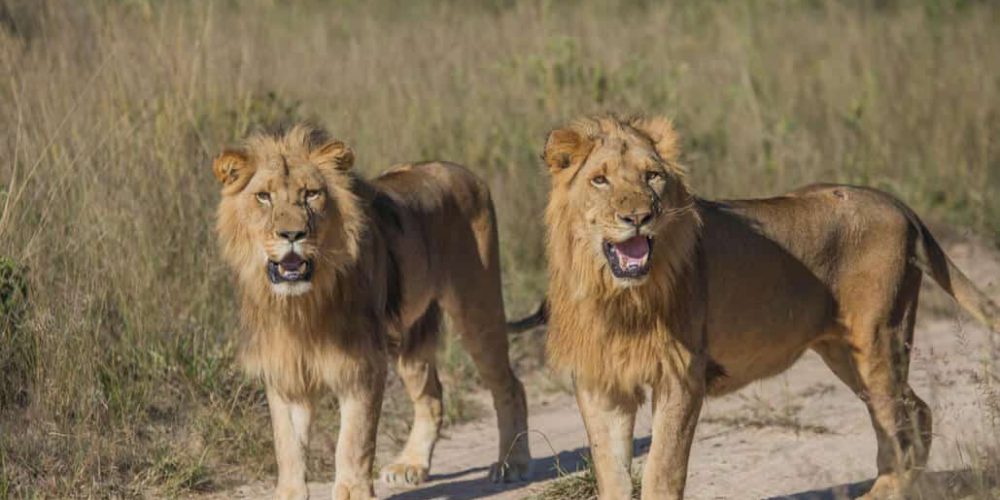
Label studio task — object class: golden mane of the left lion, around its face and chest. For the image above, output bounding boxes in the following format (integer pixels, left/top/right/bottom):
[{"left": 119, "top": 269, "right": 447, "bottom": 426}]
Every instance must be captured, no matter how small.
[{"left": 216, "top": 125, "right": 387, "bottom": 396}]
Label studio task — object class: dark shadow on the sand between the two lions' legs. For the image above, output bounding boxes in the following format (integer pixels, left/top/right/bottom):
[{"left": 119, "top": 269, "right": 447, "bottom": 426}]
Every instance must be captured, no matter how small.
[{"left": 389, "top": 437, "right": 650, "bottom": 500}]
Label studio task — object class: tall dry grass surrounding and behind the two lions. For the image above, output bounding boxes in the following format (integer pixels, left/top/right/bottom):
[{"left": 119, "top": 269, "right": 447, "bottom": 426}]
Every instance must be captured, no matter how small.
[{"left": 0, "top": 0, "right": 1000, "bottom": 495}]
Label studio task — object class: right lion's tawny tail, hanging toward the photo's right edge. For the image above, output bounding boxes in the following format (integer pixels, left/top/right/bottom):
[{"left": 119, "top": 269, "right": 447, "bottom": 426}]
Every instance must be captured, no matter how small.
[{"left": 911, "top": 214, "right": 1000, "bottom": 333}]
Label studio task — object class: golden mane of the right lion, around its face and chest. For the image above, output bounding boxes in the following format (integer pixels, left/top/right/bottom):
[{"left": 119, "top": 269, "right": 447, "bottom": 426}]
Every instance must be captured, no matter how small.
[{"left": 545, "top": 115, "right": 701, "bottom": 400}]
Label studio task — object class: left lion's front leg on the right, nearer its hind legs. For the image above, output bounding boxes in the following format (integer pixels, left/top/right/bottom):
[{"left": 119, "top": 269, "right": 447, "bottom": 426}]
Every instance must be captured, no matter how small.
[{"left": 333, "top": 373, "right": 385, "bottom": 500}]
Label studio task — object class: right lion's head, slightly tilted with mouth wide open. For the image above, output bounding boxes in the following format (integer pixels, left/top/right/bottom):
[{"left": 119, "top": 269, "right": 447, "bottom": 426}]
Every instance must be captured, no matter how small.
[{"left": 544, "top": 119, "right": 691, "bottom": 287}]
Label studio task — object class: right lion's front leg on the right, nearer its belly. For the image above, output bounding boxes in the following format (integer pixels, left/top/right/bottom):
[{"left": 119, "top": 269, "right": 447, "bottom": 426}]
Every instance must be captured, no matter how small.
[{"left": 642, "top": 368, "right": 705, "bottom": 500}]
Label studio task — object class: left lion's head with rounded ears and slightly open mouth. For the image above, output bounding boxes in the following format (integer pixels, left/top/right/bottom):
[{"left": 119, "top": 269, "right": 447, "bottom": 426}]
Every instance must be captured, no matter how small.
[{"left": 214, "top": 129, "right": 362, "bottom": 296}]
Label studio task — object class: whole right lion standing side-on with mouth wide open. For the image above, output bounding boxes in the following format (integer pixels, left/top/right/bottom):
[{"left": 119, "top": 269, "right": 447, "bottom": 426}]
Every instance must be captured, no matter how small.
[{"left": 514, "top": 116, "right": 1000, "bottom": 499}]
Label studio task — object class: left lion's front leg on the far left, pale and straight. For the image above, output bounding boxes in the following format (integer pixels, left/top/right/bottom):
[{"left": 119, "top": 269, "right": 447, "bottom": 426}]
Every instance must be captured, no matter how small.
[{"left": 267, "top": 386, "right": 312, "bottom": 500}]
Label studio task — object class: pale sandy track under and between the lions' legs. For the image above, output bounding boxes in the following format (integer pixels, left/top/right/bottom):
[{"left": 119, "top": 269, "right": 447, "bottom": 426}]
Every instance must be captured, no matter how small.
[{"left": 215, "top": 235, "right": 1000, "bottom": 500}]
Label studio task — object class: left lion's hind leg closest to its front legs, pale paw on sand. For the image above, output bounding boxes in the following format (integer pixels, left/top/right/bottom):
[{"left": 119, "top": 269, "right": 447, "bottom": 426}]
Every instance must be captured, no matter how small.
[{"left": 381, "top": 304, "right": 443, "bottom": 486}]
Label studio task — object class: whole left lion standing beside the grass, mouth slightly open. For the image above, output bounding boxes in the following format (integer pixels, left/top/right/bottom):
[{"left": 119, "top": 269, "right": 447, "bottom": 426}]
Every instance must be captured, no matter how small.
[{"left": 213, "top": 125, "right": 530, "bottom": 499}]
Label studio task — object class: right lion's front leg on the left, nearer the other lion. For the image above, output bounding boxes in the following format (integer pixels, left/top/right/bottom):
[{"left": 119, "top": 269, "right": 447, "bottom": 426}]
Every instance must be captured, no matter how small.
[{"left": 576, "top": 383, "right": 639, "bottom": 500}]
